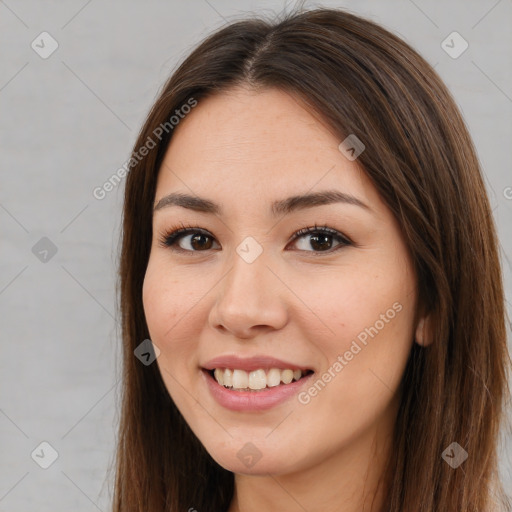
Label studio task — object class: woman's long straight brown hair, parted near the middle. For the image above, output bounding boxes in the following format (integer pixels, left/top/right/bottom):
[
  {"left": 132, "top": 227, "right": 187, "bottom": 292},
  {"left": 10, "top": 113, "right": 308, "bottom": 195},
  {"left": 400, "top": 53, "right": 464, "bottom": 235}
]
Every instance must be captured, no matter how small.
[{"left": 113, "top": 5, "right": 510, "bottom": 512}]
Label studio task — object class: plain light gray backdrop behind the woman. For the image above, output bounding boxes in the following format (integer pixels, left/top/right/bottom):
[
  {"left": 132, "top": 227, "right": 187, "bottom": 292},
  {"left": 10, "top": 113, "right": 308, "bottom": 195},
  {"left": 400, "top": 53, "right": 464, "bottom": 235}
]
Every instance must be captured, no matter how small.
[{"left": 0, "top": 0, "right": 512, "bottom": 512}]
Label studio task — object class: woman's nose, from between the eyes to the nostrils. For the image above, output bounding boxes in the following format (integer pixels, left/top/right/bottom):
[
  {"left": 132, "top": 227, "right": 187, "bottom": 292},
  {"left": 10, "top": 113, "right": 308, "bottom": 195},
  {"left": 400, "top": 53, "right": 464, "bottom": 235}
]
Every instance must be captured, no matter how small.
[{"left": 209, "top": 248, "right": 288, "bottom": 339}]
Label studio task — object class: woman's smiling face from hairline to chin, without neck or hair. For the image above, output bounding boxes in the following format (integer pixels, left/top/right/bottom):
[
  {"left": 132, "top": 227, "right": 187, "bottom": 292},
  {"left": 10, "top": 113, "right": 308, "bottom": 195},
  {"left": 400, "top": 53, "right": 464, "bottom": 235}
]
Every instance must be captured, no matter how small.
[{"left": 143, "top": 88, "right": 416, "bottom": 474}]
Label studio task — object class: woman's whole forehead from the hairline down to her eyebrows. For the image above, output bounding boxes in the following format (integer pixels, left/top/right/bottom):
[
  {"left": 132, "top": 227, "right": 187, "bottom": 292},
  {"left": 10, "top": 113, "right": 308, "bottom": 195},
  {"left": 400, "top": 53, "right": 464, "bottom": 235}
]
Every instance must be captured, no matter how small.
[{"left": 156, "top": 87, "right": 379, "bottom": 215}]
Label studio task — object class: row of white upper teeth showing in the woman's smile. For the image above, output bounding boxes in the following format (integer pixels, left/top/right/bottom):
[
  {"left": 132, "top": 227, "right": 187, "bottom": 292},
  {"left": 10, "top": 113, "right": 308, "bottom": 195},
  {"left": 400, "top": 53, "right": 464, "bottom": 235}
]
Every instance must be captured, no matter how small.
[{"left": 214, "top": 368, "right": 302, "bottom": 389}]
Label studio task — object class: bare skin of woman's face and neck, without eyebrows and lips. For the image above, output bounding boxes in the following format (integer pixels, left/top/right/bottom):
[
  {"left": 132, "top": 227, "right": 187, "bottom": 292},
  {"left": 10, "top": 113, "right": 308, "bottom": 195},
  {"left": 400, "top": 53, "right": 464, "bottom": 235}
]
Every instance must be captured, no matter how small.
[{"left": 143, "top": 86, "right": 426, "bottom": 512}]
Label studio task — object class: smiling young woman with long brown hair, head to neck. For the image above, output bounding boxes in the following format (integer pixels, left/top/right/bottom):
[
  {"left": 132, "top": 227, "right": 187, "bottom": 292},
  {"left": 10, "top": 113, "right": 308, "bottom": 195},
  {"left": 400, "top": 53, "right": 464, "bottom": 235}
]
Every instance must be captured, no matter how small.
[{"left": 114, "top": 5, "right": 510, "bottom": 512}]
